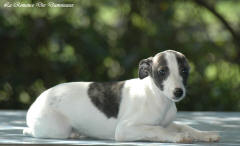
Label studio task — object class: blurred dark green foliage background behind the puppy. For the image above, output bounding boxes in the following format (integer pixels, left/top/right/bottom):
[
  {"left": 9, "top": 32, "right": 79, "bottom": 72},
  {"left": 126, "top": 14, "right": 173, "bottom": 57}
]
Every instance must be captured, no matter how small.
[{"left": 0, "top": 0, "right": 240, "bottom": 111}]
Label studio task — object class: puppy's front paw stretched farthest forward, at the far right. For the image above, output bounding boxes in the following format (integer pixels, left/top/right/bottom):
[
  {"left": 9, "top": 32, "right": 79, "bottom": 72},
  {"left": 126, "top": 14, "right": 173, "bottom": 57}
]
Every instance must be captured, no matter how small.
[{"left": 201, "top": 131, "right": 220, "bottom": 142}]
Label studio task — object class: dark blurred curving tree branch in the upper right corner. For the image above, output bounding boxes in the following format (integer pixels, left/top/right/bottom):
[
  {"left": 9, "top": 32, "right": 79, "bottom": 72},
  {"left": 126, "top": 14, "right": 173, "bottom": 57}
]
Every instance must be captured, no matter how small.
[{"left": 194, "top": 0, "right": 240, "bottom": 63}]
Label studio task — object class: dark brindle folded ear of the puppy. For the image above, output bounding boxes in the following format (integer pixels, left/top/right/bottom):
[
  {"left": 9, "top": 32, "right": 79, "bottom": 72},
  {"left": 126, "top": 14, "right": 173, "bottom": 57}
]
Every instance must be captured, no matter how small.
[{"left": 138, "top": 57, "right": 153, "bottom": 79}]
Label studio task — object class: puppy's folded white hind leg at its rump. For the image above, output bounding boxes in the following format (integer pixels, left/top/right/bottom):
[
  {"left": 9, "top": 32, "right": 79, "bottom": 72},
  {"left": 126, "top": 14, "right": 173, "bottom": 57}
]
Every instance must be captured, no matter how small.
[{"left": 23, "top": 108, "right": 72, "bottom": 139}]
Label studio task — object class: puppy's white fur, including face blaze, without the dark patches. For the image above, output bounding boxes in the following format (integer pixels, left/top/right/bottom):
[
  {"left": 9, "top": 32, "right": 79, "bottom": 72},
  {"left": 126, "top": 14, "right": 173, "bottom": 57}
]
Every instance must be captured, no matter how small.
[{"left": 24, "top": 51, "right": 219, "bottom": 142}]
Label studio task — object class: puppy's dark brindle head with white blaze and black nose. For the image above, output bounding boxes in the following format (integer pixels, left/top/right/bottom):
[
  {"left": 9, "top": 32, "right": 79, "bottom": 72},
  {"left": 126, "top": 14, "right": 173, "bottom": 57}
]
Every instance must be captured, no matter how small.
[{"left": 138, "top": 50, "right": 190, "bottom": 102}]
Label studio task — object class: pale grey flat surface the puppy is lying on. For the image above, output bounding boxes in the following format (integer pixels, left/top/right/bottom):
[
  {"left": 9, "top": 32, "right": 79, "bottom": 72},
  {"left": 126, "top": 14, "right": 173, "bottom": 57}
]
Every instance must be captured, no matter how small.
[{"left": 0, "top": 111, "right": 240, "bottom": 146}]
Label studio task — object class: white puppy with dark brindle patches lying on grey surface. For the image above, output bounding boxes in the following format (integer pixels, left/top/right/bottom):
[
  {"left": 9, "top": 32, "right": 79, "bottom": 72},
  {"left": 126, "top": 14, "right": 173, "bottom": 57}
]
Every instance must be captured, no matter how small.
[{"left": 23, "top": 50, "right": 219, "bottom": 142}]
